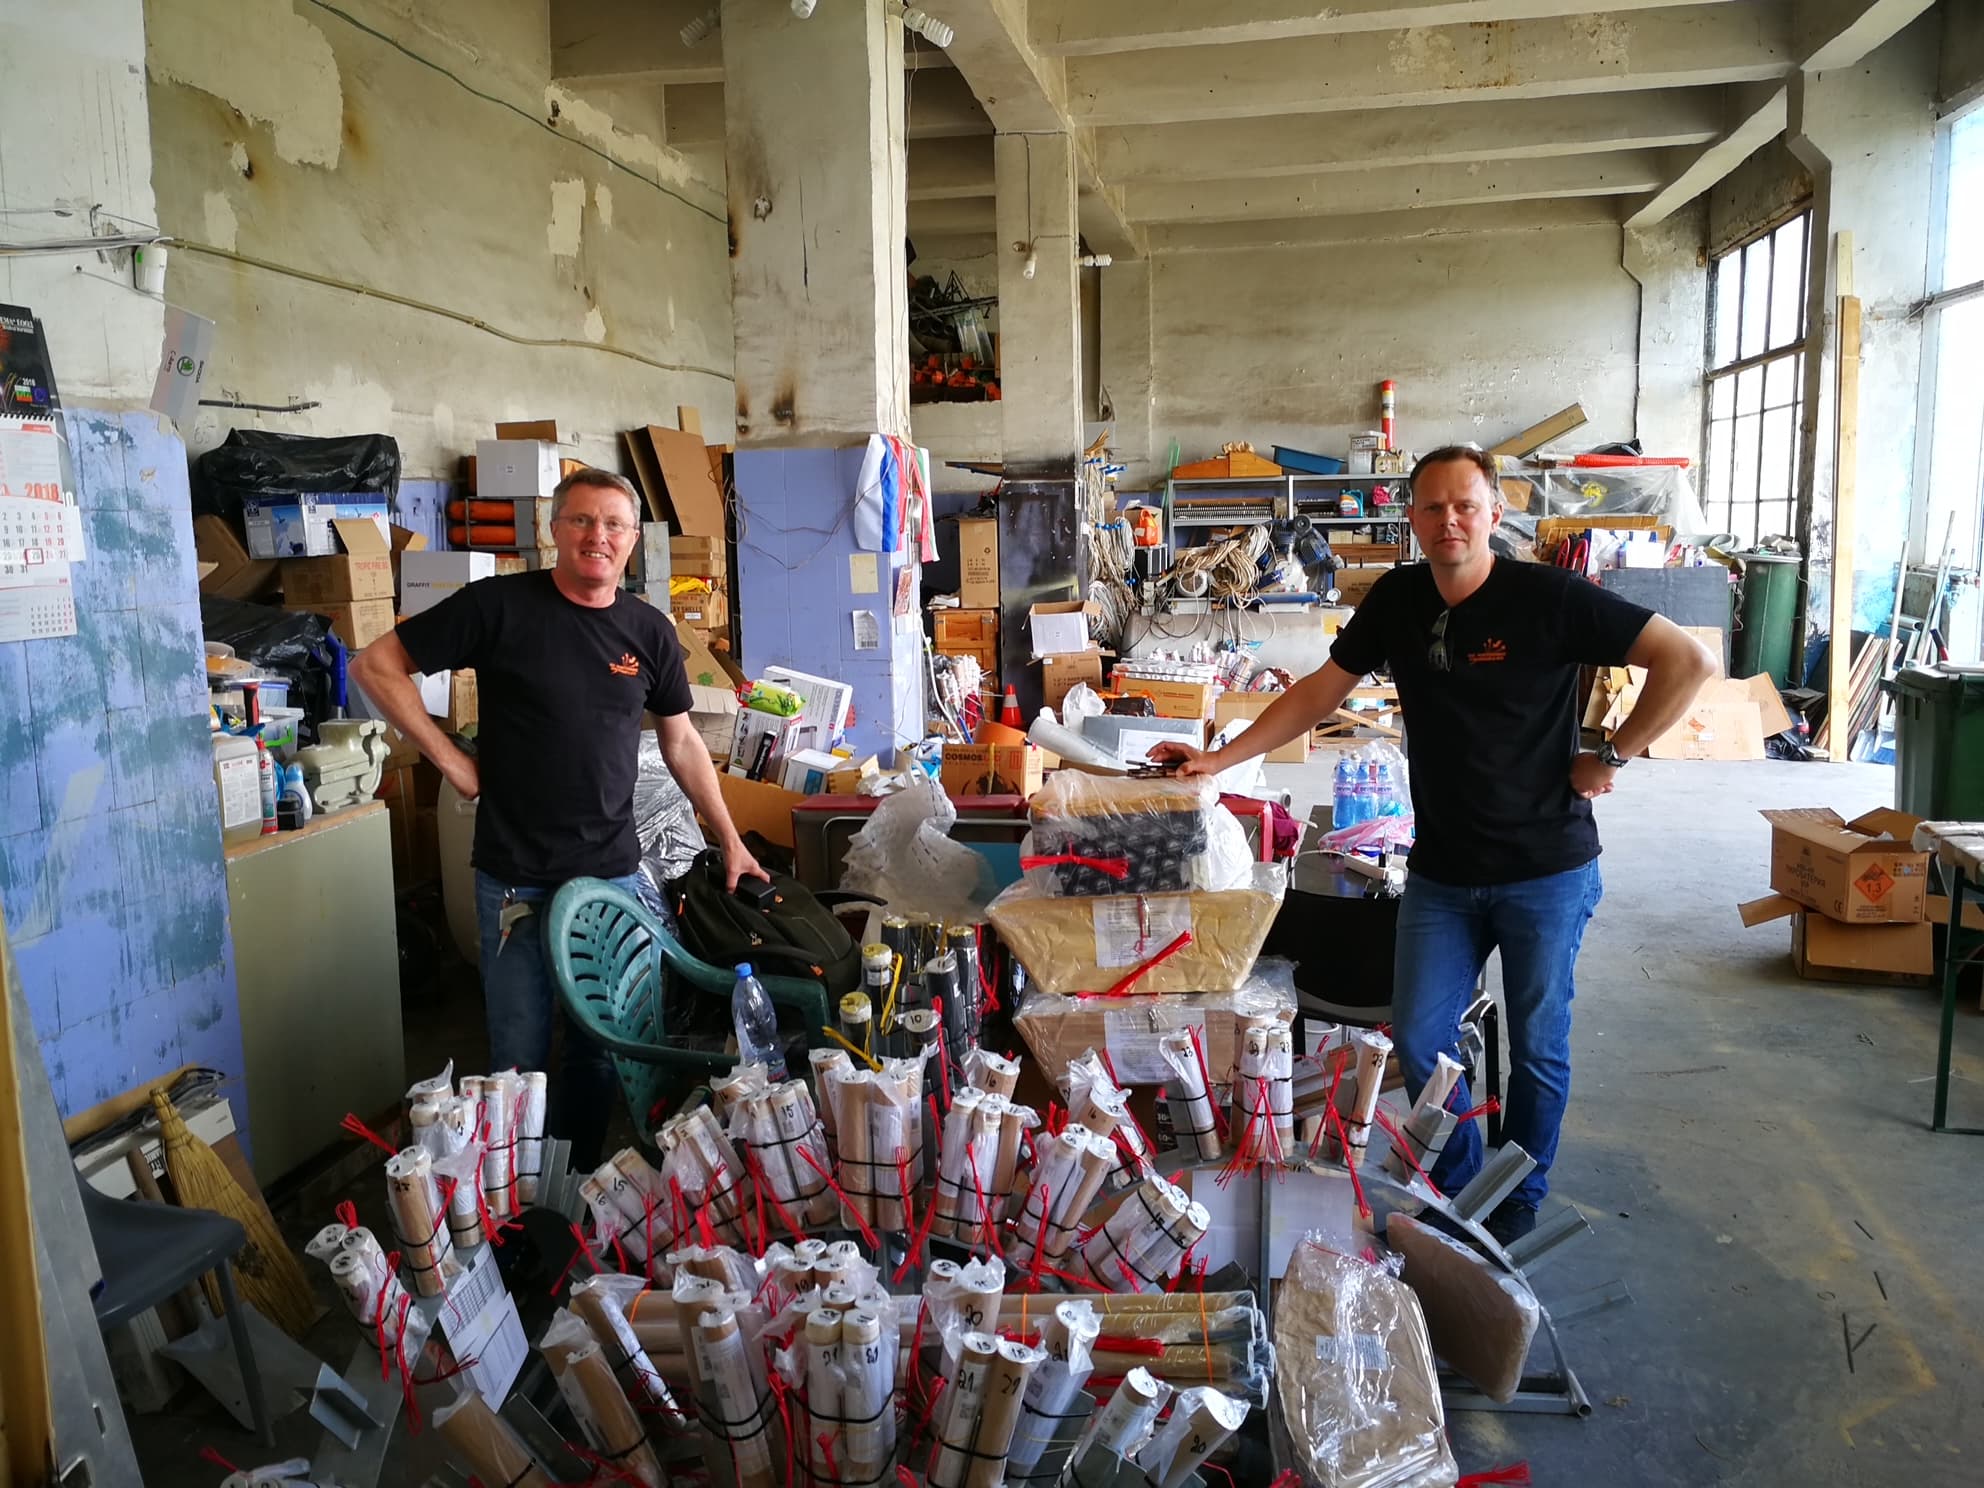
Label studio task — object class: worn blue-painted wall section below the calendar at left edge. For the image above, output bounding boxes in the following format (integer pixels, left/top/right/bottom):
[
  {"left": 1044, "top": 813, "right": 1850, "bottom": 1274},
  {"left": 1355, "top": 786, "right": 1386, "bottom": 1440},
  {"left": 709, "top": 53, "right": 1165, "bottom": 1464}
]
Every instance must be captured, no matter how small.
[{"left": 0, "top": 411, "right": 246, "bottom": 1141}]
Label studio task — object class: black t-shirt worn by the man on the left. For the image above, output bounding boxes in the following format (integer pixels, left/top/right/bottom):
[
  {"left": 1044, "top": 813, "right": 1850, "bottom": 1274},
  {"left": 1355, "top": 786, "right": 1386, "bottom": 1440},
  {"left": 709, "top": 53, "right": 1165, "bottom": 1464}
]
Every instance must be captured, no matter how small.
[{"left": 399, "top": 569, "right": 690, "bottom": 887}]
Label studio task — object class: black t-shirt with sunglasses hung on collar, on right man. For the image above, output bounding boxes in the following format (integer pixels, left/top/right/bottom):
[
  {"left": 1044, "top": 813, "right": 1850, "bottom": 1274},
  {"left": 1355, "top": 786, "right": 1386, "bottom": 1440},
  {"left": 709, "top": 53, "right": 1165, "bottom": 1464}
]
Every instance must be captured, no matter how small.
[{"left": 1329, "top": 558, "right": 1653, "bottom": 887}]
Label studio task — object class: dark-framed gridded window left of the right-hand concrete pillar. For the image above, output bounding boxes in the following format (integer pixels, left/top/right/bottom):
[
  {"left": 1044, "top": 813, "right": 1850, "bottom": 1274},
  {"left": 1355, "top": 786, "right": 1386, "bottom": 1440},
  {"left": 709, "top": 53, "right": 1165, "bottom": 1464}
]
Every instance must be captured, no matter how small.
[{"left": 1702, "top": 212, "right": 1811, "bottom": 544}]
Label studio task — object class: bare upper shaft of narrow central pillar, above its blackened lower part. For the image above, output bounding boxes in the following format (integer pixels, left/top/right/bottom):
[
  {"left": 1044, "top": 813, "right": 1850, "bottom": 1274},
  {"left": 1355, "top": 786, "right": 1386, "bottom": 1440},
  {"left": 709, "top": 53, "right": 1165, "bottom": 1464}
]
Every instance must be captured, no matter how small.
[{"left": 992, "top": 133, "right": 1081, "bottom": 462}]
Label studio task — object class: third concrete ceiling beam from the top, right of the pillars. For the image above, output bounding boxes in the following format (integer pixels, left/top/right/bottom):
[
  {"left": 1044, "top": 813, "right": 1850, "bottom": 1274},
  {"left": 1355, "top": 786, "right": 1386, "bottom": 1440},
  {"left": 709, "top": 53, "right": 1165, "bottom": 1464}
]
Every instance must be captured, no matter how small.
[{"left": 1093, "top": 87, "right": 1726, "bottom": 185}]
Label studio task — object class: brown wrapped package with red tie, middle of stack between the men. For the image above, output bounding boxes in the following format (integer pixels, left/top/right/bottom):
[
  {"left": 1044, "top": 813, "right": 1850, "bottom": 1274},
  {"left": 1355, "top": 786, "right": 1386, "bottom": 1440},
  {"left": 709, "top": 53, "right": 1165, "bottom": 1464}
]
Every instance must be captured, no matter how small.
[{"left": 986, "top": 861, "right": 1288, "bottom": 1003}]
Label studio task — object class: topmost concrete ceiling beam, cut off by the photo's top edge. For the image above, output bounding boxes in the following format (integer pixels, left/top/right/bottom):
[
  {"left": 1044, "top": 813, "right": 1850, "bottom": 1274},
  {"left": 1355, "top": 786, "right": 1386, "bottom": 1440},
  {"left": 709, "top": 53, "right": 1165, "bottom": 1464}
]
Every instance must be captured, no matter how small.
[{"left": 1028, "top": 0, "right": 1730, "bottom": 58}]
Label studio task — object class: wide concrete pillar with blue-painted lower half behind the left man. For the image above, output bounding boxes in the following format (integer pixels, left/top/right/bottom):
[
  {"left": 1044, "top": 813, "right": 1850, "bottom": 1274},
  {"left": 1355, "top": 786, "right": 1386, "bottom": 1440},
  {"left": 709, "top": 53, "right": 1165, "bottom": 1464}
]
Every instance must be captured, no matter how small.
[{"left": 722, "top": 0, "right": 923, "bottom": 752}]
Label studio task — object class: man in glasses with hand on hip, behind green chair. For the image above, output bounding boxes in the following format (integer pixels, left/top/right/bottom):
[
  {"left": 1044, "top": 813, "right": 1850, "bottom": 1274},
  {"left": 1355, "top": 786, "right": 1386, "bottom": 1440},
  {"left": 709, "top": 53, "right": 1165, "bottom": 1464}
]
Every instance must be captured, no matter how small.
[{"left": 351, "top": 470, "right": 766, "bottom": 1171}]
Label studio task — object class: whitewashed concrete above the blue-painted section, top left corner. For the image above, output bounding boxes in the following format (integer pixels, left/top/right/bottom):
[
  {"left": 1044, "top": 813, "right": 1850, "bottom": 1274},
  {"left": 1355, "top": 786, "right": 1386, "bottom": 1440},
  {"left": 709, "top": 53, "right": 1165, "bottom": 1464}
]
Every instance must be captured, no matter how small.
[{"left": 0, "top": 0, "right": 165, "bottom": 403}]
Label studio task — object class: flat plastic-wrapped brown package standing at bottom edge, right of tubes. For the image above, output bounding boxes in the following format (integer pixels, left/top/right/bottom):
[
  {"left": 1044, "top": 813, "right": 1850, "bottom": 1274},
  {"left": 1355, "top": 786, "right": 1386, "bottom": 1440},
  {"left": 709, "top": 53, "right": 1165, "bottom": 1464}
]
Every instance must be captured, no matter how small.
[{"left": 1274, "top": 1240, "right": 1460, "bottom": 1488}]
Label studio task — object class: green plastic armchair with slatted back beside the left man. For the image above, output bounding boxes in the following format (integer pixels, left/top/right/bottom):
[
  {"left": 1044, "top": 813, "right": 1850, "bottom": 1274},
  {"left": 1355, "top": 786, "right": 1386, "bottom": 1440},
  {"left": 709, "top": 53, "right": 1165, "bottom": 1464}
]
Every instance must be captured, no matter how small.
[{"left": 544, "top": 879, "right": 829, "bottom": 1143}]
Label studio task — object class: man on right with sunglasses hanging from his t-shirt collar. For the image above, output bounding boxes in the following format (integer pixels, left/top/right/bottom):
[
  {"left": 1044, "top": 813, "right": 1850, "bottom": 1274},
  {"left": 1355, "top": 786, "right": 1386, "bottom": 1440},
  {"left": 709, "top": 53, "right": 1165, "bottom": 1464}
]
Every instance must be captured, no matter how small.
[{"left": 1157, "top": 444, "right": 1716, "bottom": 1244}]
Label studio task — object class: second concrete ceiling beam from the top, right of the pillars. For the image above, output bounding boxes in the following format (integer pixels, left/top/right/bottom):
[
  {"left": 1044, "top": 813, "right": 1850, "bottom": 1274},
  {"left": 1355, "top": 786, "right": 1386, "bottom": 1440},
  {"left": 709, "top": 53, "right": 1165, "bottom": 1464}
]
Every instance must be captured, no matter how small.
[{"left": 1071, "top": 0, "right": 1796, "bottom": 127}]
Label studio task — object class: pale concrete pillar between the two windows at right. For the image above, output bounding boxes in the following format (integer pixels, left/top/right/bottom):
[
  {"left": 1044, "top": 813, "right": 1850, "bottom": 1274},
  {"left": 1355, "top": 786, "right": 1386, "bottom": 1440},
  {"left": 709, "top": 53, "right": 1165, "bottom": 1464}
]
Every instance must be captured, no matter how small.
[{"left": 1786, "top": 16, "right": 1936, "bottom": 670}]
